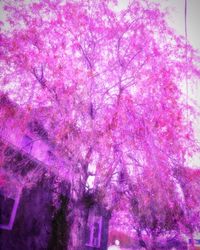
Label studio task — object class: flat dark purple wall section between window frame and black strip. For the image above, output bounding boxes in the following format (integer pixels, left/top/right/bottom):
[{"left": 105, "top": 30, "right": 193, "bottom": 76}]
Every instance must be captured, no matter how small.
[{"left": 0, "top": 177, "right": 52, "bottom": 250}]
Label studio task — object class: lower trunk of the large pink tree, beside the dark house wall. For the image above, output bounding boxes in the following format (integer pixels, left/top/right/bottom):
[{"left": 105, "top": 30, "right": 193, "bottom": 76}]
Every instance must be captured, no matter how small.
[{"left": 67, "top": 205, "right": 87, "bottom": 250}]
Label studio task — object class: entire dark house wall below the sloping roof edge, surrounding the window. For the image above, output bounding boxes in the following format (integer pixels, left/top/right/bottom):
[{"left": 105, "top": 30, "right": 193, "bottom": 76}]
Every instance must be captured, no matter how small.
[{"left": 0, "top": 141, "right": 69, "bottom": 250}]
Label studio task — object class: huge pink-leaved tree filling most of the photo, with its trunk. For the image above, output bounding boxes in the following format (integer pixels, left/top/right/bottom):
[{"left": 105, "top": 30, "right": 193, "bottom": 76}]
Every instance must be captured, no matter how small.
[{"left": 0, "top": 0, "right": 200, "bottom": 250}]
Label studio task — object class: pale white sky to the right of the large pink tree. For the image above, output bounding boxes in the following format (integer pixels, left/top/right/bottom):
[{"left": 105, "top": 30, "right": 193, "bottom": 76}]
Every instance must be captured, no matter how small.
[{"left": 116, "top": 0, "right": 200, "bottom": 167}]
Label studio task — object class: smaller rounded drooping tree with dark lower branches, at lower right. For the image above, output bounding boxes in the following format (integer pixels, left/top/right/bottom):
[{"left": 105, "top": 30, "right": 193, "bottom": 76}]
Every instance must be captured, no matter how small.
[{"left": 127, "top": 167, "right": 187, "bottom": 249}]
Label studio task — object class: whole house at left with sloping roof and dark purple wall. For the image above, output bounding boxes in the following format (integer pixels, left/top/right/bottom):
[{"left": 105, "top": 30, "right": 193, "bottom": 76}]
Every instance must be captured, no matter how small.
[{"left": 0, "top": 94, "right": 70, "bottom": 250}]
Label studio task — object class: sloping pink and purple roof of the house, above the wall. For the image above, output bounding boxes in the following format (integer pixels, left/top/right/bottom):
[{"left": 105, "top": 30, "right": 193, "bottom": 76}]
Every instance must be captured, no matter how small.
[{"left": 0, "top": 94, "right": 54, "bottom": 165}]
